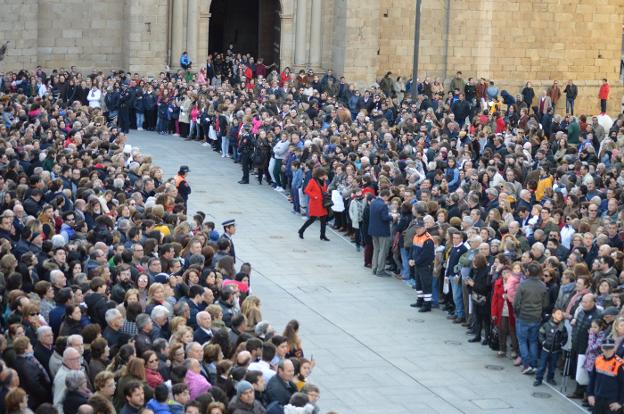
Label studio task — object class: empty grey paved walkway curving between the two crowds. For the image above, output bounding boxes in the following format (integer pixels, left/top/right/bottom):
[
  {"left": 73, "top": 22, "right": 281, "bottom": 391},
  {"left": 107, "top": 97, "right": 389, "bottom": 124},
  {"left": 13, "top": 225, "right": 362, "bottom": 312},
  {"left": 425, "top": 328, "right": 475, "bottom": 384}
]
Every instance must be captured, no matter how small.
[{"left": 130, "top": 131, "right": 583, "bottom": 414}]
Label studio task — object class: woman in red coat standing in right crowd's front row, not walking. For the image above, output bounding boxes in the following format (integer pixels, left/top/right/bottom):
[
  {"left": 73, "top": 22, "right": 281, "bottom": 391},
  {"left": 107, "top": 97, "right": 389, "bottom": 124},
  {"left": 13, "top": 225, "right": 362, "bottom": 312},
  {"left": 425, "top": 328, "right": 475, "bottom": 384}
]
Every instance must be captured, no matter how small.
[{"left": 491, "top": 269, "right": 518, "bottom": 363}]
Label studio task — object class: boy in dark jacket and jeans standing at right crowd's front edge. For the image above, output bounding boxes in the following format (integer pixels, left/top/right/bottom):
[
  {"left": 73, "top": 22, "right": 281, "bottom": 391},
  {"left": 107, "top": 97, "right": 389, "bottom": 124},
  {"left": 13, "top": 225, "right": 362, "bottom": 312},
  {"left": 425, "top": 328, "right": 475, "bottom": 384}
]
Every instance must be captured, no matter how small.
[{"left": 533, "top": 309, "right": 568, "bottom": 387}]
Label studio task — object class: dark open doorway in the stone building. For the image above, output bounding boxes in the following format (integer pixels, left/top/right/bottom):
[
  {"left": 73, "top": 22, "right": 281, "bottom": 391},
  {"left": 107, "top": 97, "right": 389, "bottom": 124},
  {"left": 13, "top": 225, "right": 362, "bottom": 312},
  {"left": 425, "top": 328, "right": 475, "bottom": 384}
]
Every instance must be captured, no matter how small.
[{"left": 208, "top": 0, "right": 281, "bottom": 65}]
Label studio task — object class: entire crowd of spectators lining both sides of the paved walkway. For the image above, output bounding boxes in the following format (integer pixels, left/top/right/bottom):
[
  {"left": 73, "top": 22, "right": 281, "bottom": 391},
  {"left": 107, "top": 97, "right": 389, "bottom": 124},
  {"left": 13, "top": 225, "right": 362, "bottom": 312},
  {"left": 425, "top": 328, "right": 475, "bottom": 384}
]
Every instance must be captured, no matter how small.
[{"left": 0, "top": 51, "right": 624, "bottom": 414}]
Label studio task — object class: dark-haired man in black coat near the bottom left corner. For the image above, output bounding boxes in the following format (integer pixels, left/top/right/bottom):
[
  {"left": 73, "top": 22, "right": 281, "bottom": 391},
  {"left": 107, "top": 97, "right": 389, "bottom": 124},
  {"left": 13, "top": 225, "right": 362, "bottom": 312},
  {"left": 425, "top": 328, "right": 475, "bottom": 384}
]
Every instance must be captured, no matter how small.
[{"left": 13, "top": 336, "right": 52, "bottom": 410}]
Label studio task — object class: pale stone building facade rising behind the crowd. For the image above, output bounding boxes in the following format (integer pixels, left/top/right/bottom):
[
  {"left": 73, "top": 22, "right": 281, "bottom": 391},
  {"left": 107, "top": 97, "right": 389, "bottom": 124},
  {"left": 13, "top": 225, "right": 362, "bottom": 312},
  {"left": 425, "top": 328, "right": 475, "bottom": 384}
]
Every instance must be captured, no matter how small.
[{"left": 0, "top": 0, "right": 624, "bottom": 112}]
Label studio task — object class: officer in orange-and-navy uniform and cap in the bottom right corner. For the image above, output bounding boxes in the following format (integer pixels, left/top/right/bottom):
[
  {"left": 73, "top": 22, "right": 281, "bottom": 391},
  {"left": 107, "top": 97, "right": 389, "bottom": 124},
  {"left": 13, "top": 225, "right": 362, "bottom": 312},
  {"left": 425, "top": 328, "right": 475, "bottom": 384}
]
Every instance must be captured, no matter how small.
[{"left": 587, "top": 337, "right": 624, "bottom": 414}]
